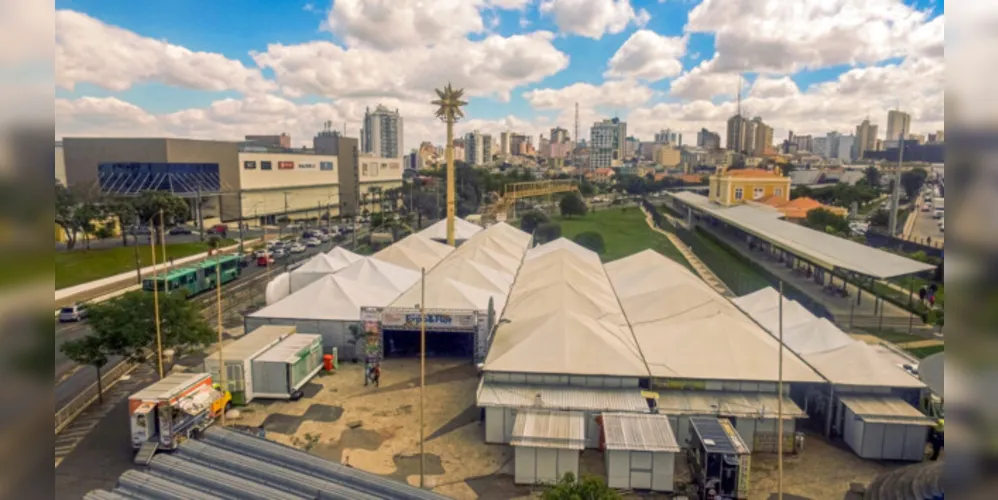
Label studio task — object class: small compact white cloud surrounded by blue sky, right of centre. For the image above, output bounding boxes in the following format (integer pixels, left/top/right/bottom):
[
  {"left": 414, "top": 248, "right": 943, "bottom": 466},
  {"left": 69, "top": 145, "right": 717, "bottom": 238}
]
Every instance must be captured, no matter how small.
[{"left": 603, "top": 29, "right": 686, "bottom": 81}]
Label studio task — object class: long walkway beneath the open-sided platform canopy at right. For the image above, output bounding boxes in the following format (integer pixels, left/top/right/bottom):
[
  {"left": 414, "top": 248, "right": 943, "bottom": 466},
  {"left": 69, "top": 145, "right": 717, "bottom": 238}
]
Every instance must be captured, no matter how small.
[{"left": 698, "top": 222, "right": 934, "bottom": 338}]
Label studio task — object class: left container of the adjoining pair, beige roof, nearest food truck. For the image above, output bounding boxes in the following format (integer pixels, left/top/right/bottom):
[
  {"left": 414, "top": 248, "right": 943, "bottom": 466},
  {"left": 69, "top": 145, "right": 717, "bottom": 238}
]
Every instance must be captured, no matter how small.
[{"left": 204, "top": 325, "right": 295, "bottom": 405}]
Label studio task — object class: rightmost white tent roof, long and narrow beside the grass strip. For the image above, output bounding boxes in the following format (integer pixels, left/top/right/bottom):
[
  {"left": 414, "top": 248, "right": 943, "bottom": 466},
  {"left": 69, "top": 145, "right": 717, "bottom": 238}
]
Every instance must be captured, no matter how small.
[{"left": 734, "top": 288, "right": 924, "bottom": 388}]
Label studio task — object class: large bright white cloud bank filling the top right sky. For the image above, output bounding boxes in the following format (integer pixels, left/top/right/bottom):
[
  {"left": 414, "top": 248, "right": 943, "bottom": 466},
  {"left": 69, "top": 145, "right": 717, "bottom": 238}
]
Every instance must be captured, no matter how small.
[{"left": 686, "top": 0, "right": 942, "bottom": 73}]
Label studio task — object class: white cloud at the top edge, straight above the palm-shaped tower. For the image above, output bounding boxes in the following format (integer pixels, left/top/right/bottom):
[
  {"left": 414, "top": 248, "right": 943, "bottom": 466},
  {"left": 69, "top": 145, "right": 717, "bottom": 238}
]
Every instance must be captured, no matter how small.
[{"left": 327, "top": 0, "right": 486, "bottom": 50}]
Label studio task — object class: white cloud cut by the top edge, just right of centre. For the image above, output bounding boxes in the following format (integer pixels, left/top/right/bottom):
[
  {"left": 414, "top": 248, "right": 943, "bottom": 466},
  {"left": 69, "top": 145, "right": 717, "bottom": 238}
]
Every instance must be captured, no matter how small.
[{"left": 540, "top": 0, "right": 651, "bottom": 40}]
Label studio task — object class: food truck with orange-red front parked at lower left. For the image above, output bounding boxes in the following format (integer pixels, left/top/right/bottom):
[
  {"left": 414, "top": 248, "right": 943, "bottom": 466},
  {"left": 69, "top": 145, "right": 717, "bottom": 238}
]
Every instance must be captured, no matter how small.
[{"left": 128, "top": 373, "right": 232, "bottom": 463}]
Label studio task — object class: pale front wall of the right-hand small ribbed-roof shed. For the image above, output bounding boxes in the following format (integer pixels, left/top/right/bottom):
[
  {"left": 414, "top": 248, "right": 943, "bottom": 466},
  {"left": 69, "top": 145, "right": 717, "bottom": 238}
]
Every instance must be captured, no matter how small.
[{"left": 605, "top": 450, "right": 676, "bottom": 491}]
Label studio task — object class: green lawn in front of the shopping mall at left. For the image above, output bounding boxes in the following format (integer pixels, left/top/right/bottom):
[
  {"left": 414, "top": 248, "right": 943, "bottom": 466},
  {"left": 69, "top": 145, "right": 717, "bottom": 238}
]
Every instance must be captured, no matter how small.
[{"left": 55, "top": 240, "right": 236, "bottom": 290}]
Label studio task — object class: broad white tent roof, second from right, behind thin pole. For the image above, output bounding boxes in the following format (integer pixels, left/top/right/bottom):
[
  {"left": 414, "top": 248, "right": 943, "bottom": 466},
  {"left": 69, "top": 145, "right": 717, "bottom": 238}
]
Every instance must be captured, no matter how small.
[{"left": 605, "top": 250, "right": 821, "bottom": 382}]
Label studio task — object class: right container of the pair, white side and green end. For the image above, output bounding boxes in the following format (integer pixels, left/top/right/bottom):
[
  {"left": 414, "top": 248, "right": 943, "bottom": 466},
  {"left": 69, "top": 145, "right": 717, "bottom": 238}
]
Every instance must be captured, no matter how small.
[{"left": 253, "top": 333, "right": 322, "bottom": 399}]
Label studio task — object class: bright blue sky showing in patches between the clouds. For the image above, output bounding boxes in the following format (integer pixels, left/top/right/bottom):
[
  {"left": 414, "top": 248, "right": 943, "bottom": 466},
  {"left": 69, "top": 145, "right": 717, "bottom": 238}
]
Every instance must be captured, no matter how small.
[{"left": 56, "top": 0, "right": 943, "bottom": 145}]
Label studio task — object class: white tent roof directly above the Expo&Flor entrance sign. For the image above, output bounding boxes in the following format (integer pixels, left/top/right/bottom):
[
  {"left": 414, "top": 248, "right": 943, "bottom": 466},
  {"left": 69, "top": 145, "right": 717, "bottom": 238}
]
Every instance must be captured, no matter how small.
[{"left": 390, "top": 223, "right": 531, "bottom": 311}]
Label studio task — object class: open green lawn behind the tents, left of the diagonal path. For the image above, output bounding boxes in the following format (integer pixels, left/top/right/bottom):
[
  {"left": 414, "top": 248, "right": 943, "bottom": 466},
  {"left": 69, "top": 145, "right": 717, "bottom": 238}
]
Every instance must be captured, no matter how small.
[{"left": 554, "top": 207, "right": 692, "bottom": 270}]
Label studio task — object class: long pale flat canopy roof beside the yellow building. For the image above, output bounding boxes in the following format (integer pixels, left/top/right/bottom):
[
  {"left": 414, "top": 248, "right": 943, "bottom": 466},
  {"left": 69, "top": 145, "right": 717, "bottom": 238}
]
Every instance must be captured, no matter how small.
[{"left": 666, "top": 191, "right": 935, "bottom": 279}]
